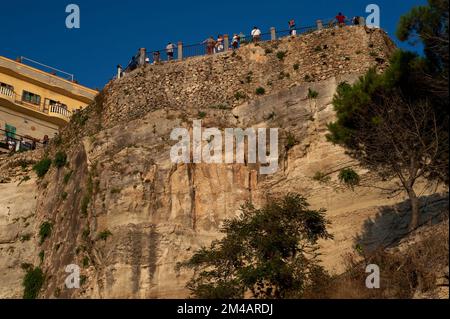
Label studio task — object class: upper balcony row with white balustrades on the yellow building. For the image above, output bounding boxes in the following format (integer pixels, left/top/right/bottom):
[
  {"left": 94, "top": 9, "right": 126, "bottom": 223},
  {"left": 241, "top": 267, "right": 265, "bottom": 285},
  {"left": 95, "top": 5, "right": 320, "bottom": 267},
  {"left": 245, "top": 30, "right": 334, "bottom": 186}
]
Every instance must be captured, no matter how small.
[{"left": 0, "top": 87, "right": 72, "bottom": 125}]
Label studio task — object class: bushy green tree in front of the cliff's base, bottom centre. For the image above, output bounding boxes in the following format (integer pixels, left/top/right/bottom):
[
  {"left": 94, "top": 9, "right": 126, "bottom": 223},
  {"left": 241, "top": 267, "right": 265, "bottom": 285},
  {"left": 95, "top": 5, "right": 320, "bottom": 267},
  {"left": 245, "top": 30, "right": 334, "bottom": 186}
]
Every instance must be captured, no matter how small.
[{"left": 177, "top": 194, "right": 331, "bottom": 299}]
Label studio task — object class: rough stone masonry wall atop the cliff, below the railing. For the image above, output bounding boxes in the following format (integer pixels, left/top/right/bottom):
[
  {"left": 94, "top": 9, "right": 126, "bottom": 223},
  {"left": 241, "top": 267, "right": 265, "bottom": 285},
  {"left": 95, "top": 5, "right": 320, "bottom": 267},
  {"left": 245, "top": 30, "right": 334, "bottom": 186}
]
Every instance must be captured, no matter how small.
[{"left": 104, "top": 26, "right": 395, "bottom": 126}]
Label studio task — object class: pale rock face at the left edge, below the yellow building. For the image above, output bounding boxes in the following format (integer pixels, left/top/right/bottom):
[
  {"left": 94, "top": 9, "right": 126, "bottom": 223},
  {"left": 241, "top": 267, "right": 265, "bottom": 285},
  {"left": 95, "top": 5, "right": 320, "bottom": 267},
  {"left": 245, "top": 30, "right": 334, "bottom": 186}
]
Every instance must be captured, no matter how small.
[{"left": 0, "top": 152, "right": 41, "bottom": 298}]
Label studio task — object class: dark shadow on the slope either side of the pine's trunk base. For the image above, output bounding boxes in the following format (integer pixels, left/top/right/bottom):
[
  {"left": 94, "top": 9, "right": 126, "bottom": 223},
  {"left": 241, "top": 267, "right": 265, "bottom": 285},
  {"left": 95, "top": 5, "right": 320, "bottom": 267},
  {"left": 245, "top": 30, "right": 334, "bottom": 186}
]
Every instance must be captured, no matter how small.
[{"left": 355, "top": 194, "right": 449, "bottom": 252}]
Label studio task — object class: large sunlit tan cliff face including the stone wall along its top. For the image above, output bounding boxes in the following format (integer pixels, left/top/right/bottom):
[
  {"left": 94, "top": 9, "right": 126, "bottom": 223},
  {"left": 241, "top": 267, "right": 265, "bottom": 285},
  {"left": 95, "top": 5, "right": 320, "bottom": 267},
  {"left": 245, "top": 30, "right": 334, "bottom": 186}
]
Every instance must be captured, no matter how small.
[{"left": 0, "top": 28, "right": 446, "bottom": 298}]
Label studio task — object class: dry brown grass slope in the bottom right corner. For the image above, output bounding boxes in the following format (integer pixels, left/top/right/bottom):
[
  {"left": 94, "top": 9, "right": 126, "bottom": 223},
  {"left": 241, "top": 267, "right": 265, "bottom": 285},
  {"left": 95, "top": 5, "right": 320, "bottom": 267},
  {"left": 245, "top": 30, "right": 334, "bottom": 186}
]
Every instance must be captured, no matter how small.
[{"left": 304, "top": 220, "right": 449, "bottom": 299}]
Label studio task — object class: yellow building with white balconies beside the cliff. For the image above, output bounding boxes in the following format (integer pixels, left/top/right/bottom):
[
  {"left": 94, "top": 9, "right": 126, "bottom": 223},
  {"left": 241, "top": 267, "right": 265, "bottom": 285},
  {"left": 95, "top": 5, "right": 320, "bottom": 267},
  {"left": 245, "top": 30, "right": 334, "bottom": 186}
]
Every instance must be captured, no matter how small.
[{"left": 0, "top": 56, "right": 98, "bottom": 142}]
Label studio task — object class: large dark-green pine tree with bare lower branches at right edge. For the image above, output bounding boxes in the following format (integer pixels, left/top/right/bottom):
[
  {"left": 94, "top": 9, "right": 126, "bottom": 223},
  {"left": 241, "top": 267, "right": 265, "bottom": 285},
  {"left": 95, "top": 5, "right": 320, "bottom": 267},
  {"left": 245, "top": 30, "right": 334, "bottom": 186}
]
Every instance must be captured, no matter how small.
[{"left": 328, "top": 0, "right": 449, "bottom": 230}]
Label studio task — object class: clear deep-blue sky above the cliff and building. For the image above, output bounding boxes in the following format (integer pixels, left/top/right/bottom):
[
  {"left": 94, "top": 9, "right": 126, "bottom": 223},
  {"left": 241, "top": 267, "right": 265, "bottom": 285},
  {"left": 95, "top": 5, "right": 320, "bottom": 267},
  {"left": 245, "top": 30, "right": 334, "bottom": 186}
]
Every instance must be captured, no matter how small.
[{"left": 0, "top": 0, "right": 426, "bottom": 88}]
